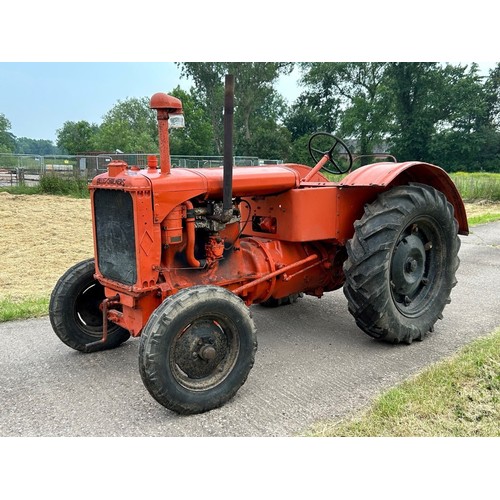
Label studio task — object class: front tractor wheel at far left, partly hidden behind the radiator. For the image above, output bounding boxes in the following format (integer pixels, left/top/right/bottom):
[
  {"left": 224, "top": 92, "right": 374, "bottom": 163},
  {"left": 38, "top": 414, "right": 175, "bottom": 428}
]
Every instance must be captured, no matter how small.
[{"left": 49, "top": 259, "right": 130, "bottom": 352}]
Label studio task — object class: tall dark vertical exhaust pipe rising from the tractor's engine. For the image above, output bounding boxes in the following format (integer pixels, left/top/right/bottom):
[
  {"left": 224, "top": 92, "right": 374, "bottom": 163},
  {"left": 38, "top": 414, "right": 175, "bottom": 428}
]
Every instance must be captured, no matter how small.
[{"left": 222, "top": 75, "right": 234, "bottom": 220}]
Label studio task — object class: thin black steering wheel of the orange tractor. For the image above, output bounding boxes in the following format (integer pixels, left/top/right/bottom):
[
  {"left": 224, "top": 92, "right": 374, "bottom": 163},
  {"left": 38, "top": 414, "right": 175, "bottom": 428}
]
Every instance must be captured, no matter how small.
[{"left": 308, "top": 132, "right": 353, "bottom": 174}]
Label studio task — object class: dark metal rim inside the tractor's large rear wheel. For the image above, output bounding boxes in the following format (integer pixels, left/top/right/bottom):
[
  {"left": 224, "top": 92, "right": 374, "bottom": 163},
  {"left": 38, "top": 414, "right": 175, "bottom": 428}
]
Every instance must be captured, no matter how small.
[{"left": 390, "top": 218, "right": 442, "bottom": 317}]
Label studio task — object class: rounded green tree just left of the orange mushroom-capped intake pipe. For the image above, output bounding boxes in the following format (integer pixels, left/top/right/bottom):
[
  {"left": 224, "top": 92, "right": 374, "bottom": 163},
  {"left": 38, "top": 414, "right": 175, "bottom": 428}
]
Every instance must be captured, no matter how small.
[{"left": 93, "top": 97, "right": 158, "bottom": 153}]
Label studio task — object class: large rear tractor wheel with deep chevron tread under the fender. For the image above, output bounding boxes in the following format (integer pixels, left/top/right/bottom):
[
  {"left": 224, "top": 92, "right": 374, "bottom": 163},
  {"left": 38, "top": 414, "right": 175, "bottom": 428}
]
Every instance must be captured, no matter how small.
[{"left": 344, "top": 184, "right": 460, "bottom": 344}]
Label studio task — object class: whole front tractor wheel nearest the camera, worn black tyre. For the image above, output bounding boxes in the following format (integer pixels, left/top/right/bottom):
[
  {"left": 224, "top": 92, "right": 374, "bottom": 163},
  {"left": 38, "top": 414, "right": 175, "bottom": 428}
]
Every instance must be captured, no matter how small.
[{"left": 139, "top": 286, "right": 257, "bottom": 414}]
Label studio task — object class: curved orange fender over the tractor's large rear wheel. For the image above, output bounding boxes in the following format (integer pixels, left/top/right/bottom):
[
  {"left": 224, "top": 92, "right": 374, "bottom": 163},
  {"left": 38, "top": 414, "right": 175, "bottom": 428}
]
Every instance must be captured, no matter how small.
[{"left": 339, "top": 161, "right": 469, "bottom": 235}]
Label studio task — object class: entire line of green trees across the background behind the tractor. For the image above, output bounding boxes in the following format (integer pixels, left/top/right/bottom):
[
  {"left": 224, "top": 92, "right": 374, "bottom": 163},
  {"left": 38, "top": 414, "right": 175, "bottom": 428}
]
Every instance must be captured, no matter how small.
[{"left": 0, "top": 62, "right": 500, "bottom": 171}]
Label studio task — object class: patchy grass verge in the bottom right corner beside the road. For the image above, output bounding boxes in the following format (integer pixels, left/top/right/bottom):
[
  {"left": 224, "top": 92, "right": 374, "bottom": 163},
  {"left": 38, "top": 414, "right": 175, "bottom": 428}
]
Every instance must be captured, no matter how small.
[{"left": 305, "top": 329, "right": 500, "bottom": 437}]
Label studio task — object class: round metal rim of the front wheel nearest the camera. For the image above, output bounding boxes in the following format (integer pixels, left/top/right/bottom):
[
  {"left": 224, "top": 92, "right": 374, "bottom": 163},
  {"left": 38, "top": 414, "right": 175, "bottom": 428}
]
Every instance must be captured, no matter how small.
[{"left": 169, "top": 316, "right": 240, "bottom": 391}]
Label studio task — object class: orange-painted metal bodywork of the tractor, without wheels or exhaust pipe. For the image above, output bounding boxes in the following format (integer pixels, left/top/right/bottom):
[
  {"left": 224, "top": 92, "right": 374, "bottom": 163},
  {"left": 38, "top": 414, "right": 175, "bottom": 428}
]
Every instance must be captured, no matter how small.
[{"left": 85, "top": 94, "right": 468, "bottom": 336}]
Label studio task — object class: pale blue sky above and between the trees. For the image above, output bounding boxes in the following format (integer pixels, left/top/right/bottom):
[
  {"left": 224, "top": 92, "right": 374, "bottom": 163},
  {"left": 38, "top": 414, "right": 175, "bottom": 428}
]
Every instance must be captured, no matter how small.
[{"left": 0, "top": 62, "right": 494, "bottom": 144}]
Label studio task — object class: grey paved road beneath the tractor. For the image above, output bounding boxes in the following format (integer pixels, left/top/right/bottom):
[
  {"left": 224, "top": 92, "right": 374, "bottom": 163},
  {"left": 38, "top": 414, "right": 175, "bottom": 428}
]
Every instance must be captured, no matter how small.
[{"left": 0, "top": 222, "right": 500, "bottom": 436}]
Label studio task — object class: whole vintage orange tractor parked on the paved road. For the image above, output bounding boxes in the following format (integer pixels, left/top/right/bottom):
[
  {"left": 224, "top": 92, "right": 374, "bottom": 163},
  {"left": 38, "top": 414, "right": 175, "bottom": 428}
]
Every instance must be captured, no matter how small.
[{"left": 50, "top": 75, "right": 468, "bottom": 414}]
